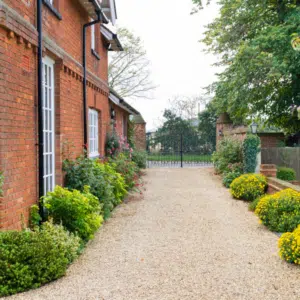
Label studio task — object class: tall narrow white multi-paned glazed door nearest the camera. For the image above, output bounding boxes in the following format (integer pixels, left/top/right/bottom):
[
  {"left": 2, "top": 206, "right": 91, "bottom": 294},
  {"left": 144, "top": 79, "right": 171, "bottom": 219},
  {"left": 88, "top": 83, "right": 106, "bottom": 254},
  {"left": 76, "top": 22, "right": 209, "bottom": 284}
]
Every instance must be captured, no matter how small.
[{"left": 43, "top": 57, "right": 55, "bottom": 195}]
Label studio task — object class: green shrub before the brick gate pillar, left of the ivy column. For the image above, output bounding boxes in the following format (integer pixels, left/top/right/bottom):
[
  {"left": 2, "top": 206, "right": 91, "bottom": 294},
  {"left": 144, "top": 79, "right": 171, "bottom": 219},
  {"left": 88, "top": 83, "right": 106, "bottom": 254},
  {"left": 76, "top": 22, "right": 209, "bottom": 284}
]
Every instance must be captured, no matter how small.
[{"left": 213, "top": 137, "right": 243, "bottom": 174}]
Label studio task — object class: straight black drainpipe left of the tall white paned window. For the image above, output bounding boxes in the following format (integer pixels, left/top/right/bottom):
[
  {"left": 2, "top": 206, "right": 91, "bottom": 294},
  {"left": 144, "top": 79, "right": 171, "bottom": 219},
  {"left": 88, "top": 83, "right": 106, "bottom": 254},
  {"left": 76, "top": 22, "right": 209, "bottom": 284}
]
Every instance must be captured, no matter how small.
[{"left": 37, "top": 0, "right": 45, "bottom": 220}]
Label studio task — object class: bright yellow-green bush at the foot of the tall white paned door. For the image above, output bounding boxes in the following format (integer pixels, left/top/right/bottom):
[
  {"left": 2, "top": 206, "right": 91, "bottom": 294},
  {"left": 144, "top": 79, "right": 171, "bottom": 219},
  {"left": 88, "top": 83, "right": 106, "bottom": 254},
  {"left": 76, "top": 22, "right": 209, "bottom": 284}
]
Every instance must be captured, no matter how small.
[{"left": 42, "top": 186, "right": 103, "bottom": 241}]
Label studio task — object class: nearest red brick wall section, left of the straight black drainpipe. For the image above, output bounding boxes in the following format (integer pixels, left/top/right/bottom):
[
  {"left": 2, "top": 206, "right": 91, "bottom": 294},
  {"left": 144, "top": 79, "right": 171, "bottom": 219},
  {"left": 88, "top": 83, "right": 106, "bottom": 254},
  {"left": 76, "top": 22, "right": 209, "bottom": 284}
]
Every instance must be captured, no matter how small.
[{"left": 0, "top": 27, "right": 37, "bottom": 229}]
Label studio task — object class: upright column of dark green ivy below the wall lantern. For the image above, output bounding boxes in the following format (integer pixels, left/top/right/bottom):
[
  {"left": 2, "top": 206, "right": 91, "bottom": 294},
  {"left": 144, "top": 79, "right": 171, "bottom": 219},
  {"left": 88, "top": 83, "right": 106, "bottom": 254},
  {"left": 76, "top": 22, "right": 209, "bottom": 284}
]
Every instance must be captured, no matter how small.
[{"left": 243, "top": 134, "right": 260, "bottom": 173}]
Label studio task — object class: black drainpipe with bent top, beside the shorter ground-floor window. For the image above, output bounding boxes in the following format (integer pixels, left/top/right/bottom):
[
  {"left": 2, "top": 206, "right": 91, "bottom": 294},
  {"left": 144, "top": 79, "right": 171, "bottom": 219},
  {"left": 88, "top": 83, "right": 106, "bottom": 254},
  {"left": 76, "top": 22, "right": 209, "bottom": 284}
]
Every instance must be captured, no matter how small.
[{"left": 82, "top": 10, "right": 102, "bottom": 155}]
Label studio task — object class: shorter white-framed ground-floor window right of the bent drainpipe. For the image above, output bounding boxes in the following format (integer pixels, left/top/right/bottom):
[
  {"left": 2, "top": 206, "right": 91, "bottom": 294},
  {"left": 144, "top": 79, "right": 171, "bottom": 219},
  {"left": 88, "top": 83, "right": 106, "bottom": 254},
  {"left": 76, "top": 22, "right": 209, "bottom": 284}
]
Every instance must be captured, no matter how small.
[{"left": 89, "top": 108, "right": 100, "bottom": 158}]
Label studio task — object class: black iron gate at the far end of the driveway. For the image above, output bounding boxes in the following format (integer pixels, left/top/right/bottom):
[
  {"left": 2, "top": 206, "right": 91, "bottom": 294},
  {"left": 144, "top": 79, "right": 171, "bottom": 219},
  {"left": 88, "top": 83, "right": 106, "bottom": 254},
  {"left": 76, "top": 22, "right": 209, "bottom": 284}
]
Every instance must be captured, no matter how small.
[{"left": 147, "top": 133, "right": 215, "bottom": 168}]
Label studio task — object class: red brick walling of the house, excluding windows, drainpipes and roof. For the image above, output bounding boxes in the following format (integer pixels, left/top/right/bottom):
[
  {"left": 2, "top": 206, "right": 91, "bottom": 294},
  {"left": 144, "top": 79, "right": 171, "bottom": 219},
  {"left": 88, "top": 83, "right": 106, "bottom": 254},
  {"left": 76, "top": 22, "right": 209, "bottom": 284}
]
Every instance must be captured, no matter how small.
[{"left": 0, "top": 0, "right": 115, "bottom": 230}]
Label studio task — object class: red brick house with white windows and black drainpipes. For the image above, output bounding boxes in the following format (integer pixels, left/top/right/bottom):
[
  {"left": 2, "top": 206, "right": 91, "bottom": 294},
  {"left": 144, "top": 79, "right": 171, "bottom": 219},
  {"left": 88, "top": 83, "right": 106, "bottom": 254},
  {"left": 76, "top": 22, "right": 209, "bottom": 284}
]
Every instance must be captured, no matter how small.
[{"left": 0, "top": 0, "right": 139, "bottom": 230}]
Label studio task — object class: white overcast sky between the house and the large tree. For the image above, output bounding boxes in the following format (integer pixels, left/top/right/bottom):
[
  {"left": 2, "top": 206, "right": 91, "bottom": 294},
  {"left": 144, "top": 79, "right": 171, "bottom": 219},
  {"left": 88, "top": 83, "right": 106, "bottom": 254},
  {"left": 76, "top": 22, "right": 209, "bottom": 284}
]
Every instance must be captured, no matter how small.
[{"left": 116, "top": 0, "right": 218, "bottom": 131}]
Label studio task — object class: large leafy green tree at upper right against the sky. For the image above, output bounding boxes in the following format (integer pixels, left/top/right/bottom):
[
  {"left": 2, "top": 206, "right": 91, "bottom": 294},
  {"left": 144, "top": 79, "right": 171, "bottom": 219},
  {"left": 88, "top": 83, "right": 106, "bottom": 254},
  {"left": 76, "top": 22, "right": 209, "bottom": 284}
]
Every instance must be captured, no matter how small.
[{"left": 202, "top": 0, "right": 300, "bottom": 133}]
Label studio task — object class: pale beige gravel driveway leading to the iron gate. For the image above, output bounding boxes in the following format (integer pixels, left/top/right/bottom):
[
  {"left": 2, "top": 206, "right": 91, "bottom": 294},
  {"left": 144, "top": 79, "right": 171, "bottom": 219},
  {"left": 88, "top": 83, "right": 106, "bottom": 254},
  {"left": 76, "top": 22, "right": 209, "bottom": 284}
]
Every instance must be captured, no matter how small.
[{"left": 10, "top": 168, "right": 300, "bottom": 300}]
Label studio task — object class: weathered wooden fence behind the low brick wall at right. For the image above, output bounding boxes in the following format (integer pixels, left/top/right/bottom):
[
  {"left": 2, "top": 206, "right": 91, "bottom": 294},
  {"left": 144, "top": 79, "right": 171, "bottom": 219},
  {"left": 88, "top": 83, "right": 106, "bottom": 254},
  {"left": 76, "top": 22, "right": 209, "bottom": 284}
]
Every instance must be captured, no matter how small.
[{"left": 261, "top": 147, "right": 300, "bottom": 180}]
